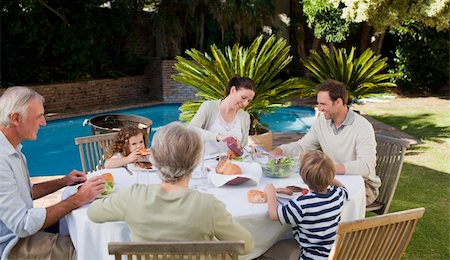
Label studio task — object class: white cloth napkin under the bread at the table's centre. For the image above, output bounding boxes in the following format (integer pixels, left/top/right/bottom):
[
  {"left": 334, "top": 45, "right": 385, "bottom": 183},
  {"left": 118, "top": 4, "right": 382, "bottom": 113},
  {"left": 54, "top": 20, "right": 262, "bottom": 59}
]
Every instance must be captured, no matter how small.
[{"left": 209, "top": 161, "right": 262, "bottom": 187}]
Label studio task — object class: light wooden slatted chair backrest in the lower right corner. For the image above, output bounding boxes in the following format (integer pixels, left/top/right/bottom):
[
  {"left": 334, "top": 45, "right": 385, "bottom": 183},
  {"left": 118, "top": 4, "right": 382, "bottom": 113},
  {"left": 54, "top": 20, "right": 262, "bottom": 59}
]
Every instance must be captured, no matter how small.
[{"left": 329, "top": 208, "right": 425, "bottom": 260}]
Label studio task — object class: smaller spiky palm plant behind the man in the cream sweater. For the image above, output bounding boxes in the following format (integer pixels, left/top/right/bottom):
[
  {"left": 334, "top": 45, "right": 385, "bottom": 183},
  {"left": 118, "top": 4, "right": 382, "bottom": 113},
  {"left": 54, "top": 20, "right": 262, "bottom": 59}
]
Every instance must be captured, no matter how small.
[{"left": 303, "top": 45, "right": 397, "bottom": 102}]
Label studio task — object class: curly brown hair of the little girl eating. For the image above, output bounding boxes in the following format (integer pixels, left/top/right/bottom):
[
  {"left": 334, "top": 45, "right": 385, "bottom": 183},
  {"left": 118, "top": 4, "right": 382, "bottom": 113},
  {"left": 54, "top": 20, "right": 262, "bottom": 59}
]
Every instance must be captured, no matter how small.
[{"left": 106, "top": 125, "right": 148, "bottom": 159}]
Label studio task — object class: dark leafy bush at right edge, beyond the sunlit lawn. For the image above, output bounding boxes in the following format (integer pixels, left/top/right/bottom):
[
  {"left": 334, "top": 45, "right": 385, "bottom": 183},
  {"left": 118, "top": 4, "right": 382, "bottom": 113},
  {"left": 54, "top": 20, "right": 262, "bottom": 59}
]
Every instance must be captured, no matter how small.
[{"left": 386, "top": 23, "right": 450, "bottom": 94}]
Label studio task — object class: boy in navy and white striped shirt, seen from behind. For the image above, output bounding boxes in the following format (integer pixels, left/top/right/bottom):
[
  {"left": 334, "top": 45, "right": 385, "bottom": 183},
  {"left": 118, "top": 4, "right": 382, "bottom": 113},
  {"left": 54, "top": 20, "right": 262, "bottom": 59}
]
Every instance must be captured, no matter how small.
[{"left": 265, "top": 151, "right": 348, "bottom": 260}]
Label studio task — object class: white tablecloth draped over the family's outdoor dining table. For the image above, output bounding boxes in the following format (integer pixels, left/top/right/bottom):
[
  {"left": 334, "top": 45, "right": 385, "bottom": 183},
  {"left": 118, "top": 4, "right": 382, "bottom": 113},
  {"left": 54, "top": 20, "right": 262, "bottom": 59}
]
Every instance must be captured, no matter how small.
[{"left": 63, "top": 164, "right": 366, "bottom": 260}]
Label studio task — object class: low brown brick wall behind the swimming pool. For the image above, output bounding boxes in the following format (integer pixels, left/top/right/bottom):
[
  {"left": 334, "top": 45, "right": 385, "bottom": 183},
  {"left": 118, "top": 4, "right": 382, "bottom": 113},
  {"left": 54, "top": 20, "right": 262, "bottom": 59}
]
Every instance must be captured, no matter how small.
[{"left": 0, "top": 60, "right": 197, "bottom": 113}]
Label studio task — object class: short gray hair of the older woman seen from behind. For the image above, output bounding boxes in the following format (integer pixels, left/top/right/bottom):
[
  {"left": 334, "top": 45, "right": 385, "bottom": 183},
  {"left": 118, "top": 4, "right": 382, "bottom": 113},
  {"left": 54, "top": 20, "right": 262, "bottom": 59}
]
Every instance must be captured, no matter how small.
[{"left": 150, "top": 122, "right": 203, "bottom": 183}]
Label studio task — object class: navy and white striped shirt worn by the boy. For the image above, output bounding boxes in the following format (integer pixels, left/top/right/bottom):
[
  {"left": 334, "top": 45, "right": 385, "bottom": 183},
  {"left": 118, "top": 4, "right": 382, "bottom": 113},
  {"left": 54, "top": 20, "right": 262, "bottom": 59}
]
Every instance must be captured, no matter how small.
[{"left": 278, "top": 186, "right": 348, "bottom": 259}]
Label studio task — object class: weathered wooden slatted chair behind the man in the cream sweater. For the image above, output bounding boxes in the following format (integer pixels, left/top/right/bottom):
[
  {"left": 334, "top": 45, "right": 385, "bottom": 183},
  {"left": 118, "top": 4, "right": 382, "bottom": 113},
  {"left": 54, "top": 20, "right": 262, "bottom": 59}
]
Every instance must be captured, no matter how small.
[{"left": 366, "top": 134, "right": 409, "bottom": 215}]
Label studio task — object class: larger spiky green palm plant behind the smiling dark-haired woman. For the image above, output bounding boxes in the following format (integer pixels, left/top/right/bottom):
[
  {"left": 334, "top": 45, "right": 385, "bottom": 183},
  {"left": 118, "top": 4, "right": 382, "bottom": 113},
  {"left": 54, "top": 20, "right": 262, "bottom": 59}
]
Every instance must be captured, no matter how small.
[{"left": 172, "top": 36, "right": 314, "bottom": 130}]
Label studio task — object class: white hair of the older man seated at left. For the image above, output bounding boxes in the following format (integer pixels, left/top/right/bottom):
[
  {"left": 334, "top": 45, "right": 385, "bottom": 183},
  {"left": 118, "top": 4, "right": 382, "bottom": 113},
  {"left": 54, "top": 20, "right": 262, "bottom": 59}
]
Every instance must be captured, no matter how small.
[{"left": 0, "top": 87, "right": 44, "bottom": 127}]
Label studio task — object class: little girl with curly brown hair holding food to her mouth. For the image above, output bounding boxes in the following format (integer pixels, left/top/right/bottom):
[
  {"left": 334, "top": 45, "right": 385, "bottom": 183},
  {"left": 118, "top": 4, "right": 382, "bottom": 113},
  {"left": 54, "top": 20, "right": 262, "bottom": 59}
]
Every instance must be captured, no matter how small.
[{"left": 105, "top": 125, "right": 148, "bottom": 168}]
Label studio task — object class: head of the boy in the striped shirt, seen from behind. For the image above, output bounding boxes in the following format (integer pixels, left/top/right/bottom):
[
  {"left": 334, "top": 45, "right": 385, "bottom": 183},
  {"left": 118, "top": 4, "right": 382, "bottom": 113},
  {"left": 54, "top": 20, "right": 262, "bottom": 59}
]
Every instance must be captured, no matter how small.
[{"left": 300, "top": 151, "right": 335, "bottom": 192}]
